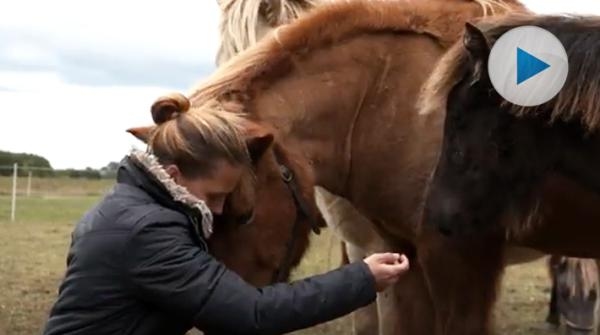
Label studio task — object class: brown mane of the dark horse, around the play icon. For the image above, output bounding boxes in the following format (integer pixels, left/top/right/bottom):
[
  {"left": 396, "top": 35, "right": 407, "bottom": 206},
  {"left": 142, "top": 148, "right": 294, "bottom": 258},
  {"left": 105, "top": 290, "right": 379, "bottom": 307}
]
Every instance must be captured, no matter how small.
[{"left": 419, "top": 13, "right": 600, "bottom": 131}]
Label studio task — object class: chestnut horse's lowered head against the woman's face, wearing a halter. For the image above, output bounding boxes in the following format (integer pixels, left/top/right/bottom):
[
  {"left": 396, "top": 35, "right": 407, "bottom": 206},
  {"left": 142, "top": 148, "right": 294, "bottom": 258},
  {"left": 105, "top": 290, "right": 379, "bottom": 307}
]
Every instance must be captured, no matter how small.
[{"left": 128, "top": 103, "right": 325, "bottom": 286}]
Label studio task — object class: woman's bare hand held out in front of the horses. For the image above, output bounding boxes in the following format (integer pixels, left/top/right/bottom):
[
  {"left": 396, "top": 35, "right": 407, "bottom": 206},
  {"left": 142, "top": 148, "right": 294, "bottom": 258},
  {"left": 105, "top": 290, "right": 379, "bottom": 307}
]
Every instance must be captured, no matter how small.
[{"left": 364, "top": 252, "right": 409, "bottom": 292}]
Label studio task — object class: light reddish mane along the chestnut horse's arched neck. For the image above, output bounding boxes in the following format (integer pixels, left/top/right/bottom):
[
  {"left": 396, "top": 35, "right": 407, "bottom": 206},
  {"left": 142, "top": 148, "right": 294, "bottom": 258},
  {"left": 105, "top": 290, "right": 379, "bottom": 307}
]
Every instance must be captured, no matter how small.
[{"left": 188, "top": 0, "right": 521, "bottom": 105}]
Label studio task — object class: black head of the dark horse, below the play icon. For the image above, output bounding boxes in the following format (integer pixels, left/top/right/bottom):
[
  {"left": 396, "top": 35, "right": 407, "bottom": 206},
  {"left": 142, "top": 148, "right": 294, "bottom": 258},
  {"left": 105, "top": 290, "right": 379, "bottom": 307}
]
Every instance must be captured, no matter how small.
[{"left": 425, "top": 21, "right": 542, "bottom": 234}]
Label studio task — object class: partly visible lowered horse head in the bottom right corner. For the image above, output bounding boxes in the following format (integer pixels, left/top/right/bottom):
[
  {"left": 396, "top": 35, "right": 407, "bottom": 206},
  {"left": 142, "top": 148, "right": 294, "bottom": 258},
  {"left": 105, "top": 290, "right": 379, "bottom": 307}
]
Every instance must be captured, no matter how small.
[{"left": 550, "top": 256, "right": 600, "bottom": 335}]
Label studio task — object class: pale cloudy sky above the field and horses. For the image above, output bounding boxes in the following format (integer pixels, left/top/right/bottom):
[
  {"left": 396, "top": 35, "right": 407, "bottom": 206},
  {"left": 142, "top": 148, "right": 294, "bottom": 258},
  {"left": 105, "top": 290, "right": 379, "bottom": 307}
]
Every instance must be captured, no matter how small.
[{"left": 0, "top": 0, "right": 600, "bottom": 169}]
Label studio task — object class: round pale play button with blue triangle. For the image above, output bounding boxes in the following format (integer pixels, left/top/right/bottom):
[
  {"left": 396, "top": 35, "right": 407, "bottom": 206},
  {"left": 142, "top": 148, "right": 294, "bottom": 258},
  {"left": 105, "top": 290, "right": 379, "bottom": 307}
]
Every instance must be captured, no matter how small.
[{"left": 488, "top": 26, "right": 569, "bottom": 106}]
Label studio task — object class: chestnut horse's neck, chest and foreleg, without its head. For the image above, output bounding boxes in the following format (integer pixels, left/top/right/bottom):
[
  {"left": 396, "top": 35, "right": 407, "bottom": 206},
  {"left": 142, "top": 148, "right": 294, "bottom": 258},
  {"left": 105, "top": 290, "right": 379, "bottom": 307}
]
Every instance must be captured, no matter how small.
[{"left": 185, "top": 0, "right": 532, "bottom": 334}]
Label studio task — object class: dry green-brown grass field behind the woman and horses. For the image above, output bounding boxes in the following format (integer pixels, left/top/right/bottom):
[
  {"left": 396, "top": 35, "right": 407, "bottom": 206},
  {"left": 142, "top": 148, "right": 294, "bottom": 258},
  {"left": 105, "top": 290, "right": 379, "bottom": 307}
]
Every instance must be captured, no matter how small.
[{"left": 0, "top": 178, "right": 554, "bottom": 335}]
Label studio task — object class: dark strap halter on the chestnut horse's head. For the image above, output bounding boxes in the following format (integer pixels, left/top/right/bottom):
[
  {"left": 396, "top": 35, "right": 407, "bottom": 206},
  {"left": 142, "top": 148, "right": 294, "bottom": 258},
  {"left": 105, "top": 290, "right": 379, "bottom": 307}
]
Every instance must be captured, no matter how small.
[{"left": 271, "top": 159, "right": 321, "bottom": 283}]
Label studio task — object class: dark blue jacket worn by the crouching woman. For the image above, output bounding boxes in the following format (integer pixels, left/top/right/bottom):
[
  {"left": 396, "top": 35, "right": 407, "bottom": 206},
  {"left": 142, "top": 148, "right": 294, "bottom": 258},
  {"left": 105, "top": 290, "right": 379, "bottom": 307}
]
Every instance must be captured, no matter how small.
[{"left": 43, "top": 158, "right": 376, "bottom": 335}]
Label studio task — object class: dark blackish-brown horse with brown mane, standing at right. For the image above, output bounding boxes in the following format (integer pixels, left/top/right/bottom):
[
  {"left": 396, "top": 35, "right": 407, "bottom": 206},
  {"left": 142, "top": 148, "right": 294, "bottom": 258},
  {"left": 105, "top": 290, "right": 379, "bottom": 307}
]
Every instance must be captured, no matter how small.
[{"left": 420, "top": 15, "right": 600, "bottom": 333}]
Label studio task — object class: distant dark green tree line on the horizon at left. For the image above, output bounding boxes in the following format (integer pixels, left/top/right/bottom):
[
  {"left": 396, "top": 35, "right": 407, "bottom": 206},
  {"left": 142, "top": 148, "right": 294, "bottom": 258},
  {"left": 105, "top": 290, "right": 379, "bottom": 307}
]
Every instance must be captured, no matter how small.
[{"left": 0, "top": 150, "right": 119, "bottom": 179}]
